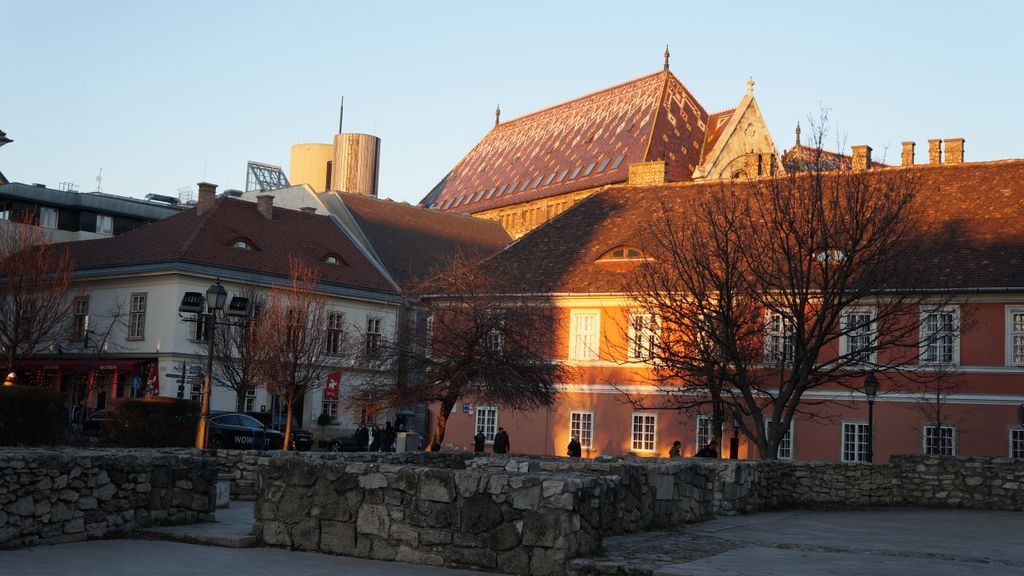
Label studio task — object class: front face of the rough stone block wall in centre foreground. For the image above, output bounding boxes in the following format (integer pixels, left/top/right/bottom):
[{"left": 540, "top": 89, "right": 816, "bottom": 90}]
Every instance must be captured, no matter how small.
[{"left": 254, "top": 457, "right": 610, "bottom": 574}]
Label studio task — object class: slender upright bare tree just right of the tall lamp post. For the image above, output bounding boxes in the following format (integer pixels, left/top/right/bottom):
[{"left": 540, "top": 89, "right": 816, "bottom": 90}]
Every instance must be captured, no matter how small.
[{"left": 251, "top": 258, "right": 341, "bottom": 450}]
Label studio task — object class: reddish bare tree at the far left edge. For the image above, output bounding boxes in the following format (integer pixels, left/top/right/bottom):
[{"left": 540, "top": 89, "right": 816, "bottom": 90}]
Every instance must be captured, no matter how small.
[{"left": 0, "top": 214, "right": 74, "bottom": 371}]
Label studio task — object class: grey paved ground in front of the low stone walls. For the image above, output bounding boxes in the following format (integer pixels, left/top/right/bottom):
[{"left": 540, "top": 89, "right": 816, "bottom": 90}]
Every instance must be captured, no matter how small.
[{"left": 0, "top": 503, "right": 1024, "bottom": 576}]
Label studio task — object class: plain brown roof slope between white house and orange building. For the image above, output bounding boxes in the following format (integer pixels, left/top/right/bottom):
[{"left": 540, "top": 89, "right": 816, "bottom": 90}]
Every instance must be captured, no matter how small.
[{"left": 336, "top": 193, "right": 511, "bottom": 288}]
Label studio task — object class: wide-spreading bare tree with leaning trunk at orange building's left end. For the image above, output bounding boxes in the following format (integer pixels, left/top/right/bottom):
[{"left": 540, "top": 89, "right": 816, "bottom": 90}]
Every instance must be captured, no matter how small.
[{"left": 350, "top": 255, "right": 569, "bottom": 450}]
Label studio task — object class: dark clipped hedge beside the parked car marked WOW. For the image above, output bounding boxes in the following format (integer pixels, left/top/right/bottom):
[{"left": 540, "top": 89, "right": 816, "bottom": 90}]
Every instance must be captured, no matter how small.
[{"left": 106, "top": 398, "right": 200, "bottom": 448}]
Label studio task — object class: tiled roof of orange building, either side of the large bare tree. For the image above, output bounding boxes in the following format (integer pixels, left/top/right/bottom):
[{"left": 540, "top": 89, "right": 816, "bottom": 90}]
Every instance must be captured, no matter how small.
[{"left": 483, "top": 160, "right": 1024, "bottom": 293}]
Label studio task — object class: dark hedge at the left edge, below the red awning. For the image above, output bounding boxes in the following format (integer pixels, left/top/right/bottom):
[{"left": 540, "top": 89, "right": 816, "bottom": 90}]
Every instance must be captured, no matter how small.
[{"left": 0, "top": 386, "right": 63, "bottom": 446}]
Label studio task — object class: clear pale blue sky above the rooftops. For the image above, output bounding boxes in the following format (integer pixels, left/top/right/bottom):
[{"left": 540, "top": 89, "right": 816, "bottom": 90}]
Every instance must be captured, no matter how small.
[{"left": 0, "top": 0, "right": 1024, "bottom": 202}]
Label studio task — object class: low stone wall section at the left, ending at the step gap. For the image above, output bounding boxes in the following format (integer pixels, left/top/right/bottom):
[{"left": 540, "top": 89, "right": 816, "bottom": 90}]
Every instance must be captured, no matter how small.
[{"left": 0, "top": 448, "right": 217, "bottom": 547}]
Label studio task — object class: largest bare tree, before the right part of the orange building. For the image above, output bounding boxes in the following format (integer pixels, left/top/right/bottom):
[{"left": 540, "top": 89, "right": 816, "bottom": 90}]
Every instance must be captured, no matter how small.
[{"left": 629, "top": 121, "right": 967, "bottom": 459}]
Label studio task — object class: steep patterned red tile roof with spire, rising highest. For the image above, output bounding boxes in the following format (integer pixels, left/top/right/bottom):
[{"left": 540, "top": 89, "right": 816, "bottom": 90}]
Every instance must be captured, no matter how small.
[{"left": 421, "top": 71, "right": 708, "bottom": 213}]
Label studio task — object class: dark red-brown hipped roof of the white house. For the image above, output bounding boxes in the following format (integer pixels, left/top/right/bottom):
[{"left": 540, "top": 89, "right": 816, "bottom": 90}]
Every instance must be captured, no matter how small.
[{"left": 63, "top": 197, "right": 393, "bottom": 293}]
